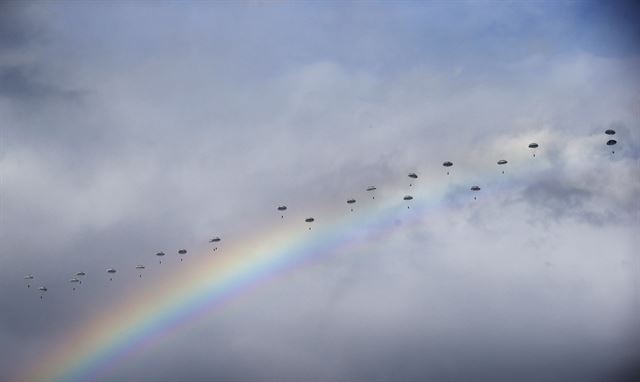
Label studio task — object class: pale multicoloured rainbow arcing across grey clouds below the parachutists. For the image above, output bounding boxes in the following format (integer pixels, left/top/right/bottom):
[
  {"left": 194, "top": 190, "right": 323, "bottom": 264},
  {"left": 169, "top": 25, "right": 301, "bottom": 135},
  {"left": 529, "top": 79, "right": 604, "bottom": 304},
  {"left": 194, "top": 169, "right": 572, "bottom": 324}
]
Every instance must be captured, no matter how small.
[{"left": 18, "top": 157, "right": 540, "bottom": 382}]
